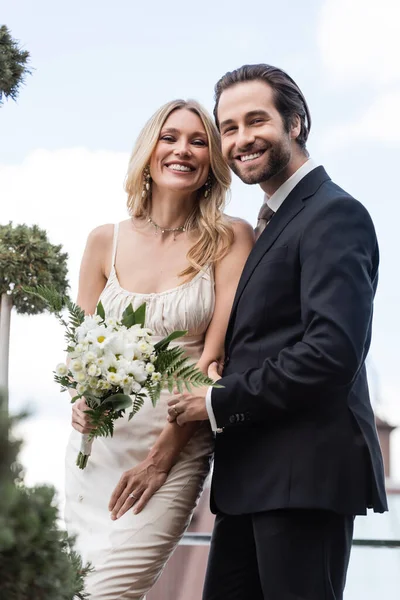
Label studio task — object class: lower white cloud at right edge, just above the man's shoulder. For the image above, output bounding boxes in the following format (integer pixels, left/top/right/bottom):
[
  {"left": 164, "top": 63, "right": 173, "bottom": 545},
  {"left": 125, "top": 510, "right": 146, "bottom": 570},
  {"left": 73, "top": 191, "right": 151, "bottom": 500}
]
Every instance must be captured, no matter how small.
[{"left": 324, "top": 89, "right": 400, "bottom": 150}]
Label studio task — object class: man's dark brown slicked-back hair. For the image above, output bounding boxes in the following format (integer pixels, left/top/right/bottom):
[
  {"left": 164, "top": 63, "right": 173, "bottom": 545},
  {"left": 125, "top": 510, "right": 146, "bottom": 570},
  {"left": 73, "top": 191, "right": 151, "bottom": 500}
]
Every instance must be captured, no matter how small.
[{"left": 214, "top": 64, "right": 311, "bottom": 150}]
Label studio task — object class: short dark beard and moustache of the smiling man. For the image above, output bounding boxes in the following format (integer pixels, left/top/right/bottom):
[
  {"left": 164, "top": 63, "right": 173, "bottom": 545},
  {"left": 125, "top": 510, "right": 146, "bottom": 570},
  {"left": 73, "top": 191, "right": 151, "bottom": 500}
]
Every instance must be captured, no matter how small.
[{"left": 229, "top": 141, "right": 291, "bottom": 185}]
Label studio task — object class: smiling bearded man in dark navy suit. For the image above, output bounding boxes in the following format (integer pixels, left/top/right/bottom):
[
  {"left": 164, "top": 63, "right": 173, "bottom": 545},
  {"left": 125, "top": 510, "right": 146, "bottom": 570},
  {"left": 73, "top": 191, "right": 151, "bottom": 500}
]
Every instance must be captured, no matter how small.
[{"left": 169, "top": 64, "right": 387, "bottom": 600}]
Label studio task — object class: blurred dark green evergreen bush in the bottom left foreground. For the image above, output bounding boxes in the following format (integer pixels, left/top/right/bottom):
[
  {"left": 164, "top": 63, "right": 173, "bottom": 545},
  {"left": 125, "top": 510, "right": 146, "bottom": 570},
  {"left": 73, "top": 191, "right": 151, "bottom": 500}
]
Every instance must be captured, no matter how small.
[{"left": 0, "top": 398, "right": 89, "bottom": 600}]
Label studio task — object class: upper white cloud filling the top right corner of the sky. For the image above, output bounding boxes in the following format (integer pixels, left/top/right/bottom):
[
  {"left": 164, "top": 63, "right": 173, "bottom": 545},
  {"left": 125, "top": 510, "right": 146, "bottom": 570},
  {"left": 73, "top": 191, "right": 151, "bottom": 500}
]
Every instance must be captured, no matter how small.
[{"left": 318, "top": 0, "right": 400, "bottom": 86}]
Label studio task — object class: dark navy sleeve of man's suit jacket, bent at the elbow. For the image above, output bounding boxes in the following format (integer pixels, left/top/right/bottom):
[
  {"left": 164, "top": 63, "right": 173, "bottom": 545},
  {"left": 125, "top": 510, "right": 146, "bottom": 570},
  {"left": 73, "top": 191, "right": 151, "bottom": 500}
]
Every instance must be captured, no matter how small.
[{"left": 212, "top": 197, "right": 379, "bottom": 427}]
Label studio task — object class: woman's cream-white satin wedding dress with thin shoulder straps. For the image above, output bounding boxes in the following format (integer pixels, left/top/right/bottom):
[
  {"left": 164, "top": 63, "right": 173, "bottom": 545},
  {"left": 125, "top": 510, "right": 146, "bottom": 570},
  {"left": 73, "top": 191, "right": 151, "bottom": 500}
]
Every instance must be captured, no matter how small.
[{"left": 65, "top": 225, "right": 215, "bottom": 600}]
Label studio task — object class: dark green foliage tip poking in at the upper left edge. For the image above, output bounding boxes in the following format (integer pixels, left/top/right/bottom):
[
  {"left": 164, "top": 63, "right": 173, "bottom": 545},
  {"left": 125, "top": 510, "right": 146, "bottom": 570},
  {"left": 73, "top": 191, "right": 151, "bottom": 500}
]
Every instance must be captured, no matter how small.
[{"left": 0, "top": 25, "right": 31, "bottom": 106}]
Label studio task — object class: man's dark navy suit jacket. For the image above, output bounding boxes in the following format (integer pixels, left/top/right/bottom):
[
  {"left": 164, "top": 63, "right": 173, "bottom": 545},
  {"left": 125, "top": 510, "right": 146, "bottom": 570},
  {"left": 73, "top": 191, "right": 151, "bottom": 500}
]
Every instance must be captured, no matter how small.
[{"left": 211, "top": 167, "right": 387, "bottom": 515}]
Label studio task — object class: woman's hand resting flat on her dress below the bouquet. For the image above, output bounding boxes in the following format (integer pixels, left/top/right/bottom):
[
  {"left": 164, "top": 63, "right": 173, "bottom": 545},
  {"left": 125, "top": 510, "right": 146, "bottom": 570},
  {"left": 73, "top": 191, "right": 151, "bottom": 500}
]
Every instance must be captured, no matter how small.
[{"left": 108, "top": 458, "right": 168, "bottom": 521}]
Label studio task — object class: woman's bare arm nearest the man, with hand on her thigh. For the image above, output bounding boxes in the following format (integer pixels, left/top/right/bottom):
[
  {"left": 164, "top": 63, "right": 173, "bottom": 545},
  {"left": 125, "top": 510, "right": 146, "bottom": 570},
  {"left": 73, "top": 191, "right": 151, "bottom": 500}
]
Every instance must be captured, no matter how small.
[{"left": 109, "top": 220, "right": 254, "bottom": 519}]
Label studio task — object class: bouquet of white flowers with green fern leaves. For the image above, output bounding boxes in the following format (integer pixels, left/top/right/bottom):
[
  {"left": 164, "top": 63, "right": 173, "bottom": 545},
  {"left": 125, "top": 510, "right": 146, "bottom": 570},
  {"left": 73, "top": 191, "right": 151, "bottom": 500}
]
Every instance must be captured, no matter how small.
[{"left": 25, "top": 287, "right": 215, "bottom": 469}]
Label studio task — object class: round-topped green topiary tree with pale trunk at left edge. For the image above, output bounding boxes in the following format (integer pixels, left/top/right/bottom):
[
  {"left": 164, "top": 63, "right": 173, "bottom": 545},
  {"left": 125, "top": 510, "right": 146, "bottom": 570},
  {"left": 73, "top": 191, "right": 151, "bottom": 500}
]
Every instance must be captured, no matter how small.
[{"left": 0, "top": 223, "right": 68, "bottom": 406}]
